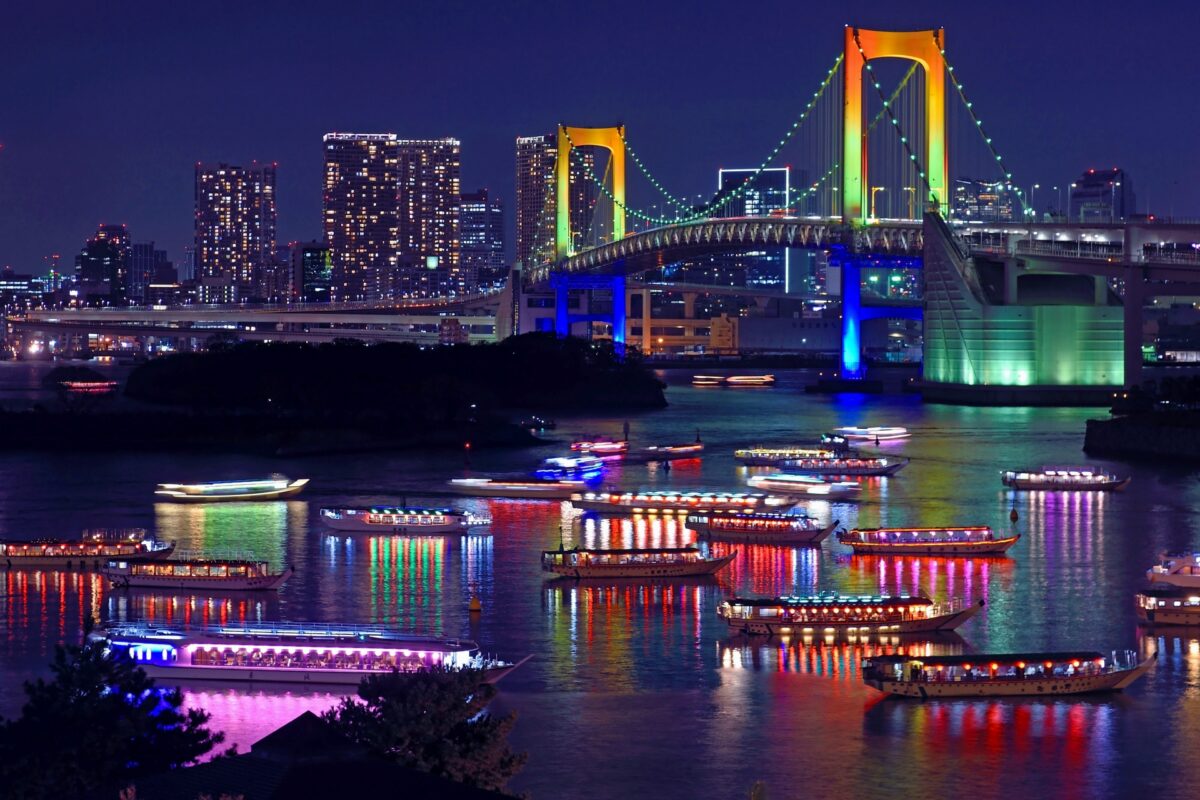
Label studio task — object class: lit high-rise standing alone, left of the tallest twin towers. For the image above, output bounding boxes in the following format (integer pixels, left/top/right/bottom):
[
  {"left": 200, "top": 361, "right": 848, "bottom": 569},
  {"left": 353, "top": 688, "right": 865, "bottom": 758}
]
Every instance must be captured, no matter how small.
[{"left": 196, "top": 163, "right": 276, "bottom": 302}]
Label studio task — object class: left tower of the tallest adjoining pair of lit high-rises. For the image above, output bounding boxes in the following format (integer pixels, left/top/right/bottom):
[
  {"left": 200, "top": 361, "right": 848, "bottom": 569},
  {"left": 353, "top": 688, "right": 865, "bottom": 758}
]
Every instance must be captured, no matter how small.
[{"left": 323, "top": 133, "right": 400, "bottom": 301}]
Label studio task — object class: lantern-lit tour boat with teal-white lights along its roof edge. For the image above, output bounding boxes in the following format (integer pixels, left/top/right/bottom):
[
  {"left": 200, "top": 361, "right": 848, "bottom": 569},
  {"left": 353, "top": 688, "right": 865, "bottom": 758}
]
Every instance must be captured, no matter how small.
[{"left": 716, "top": 593, "right": 983, "bottom": 636}]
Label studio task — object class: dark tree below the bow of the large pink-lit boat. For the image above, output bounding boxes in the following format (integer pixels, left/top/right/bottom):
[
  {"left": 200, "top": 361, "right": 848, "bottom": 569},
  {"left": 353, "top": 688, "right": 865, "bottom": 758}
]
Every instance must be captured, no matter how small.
[{"left": 324, "top": 669, "right": 526, "bottom": 790}]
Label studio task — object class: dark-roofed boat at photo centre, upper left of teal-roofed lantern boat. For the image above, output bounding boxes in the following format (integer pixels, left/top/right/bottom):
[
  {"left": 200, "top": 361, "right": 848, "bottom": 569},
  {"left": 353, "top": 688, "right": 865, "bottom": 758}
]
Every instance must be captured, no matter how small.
[{"left": 541, "top": 547, "right": 738, "bottom": 578}]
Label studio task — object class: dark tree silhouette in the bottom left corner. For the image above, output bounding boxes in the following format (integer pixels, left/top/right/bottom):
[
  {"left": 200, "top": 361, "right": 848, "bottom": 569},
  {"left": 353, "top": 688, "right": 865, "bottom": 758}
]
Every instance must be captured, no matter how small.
[{"left": 0, "top": 642, "right": 224, "bottom": 800}]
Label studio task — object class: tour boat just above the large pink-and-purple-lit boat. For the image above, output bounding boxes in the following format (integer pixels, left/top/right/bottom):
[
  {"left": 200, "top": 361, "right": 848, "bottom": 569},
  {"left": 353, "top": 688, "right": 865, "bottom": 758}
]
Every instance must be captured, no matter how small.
[{"left": 100, "top": 559, "right": 295, "bottom": 591}]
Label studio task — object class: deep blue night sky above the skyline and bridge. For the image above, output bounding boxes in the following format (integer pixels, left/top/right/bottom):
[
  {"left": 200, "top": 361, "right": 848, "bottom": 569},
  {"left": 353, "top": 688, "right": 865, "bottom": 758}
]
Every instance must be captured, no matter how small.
[{"left": 0, "top": 0, "right": 1200, "bottom": 272}]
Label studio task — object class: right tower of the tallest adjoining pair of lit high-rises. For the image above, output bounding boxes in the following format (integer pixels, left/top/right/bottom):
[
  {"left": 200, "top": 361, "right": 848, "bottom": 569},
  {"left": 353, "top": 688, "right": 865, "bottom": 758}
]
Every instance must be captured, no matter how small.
[{"left": 397, "top": 138, "right": 470, "bottom": 295}]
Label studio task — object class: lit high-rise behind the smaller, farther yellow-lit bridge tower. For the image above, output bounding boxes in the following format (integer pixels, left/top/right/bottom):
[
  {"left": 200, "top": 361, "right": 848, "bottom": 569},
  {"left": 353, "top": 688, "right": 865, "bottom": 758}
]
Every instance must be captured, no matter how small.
[{"left": 516, "top": 133, "right": 598, "bottom": 267}]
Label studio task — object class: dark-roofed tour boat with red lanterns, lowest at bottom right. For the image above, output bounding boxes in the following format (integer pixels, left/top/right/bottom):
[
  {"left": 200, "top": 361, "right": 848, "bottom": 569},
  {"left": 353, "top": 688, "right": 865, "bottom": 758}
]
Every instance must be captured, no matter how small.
[{"left": 863, "top": 650, "right": 1154, "bottom": 699}]
